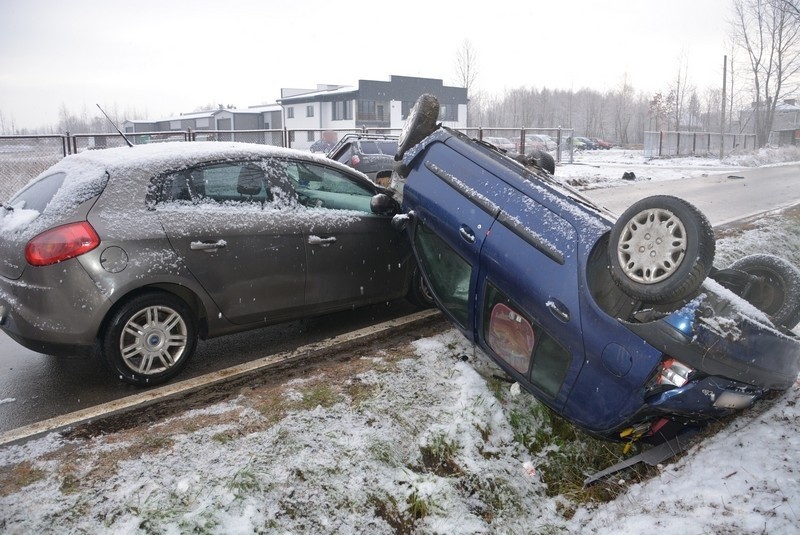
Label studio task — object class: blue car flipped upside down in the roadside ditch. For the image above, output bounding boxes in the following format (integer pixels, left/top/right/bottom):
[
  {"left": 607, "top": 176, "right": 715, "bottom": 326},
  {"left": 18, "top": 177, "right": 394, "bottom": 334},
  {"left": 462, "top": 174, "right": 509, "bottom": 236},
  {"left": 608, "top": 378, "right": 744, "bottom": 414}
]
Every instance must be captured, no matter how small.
[{"left": 373, "top": 95, "right": 800, "bottom": 443}]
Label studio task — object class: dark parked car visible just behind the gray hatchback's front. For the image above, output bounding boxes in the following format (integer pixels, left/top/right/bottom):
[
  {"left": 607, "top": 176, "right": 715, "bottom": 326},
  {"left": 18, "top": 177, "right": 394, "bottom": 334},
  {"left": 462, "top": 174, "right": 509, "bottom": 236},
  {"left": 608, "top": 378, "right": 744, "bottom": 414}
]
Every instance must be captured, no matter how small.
[{"left": 328, "top": 134, "right": 397, "bottom": 186}]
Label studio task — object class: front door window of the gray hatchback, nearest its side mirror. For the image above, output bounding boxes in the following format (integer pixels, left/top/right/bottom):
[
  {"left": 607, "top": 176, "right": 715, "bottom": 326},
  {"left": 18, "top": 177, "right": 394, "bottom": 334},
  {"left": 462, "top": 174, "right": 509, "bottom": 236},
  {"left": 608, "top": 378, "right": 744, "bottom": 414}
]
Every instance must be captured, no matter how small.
[{"left": 286, "top": 161, "right": 375, "bottom": 214}]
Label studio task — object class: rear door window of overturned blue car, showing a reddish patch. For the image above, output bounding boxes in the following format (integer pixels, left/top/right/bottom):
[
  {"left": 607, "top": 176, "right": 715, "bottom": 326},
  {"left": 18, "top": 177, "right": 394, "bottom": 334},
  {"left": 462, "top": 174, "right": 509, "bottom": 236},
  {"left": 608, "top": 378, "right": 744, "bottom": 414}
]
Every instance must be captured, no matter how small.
[{"left": 483, "top": 284, "right": 570, "bottom": 397}]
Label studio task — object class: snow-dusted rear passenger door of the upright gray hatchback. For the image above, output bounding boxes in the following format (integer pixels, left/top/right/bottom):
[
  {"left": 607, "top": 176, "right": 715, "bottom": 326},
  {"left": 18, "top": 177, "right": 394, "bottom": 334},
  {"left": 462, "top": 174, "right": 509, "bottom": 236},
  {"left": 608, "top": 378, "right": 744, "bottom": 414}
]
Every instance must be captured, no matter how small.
[{"left": 154, "top": 159, "right": 306, "bottom": 324}]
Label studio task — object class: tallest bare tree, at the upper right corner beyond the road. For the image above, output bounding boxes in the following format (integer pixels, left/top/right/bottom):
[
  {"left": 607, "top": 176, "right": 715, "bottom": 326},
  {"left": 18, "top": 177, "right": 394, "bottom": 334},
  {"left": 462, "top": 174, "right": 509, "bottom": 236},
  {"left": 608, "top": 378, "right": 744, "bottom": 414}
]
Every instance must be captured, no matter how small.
[{"left": 732, "top": 0, "right": 800, "bottom": 146}]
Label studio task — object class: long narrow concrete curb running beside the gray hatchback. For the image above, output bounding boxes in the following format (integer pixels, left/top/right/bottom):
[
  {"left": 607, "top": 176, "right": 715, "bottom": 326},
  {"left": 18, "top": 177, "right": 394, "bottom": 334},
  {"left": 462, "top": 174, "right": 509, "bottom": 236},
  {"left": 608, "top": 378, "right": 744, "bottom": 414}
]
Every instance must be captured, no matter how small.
[{"left": 0, "top": 309, "right": 441, "bottom": 447}]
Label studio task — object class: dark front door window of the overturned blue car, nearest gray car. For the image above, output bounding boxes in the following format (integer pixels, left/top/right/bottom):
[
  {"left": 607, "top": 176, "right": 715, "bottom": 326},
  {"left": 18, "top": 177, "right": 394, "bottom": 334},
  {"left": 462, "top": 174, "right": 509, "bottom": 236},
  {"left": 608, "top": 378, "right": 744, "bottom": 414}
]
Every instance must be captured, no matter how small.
[{"left": 414, "top": 222, "right": 472, "bottom": 327}]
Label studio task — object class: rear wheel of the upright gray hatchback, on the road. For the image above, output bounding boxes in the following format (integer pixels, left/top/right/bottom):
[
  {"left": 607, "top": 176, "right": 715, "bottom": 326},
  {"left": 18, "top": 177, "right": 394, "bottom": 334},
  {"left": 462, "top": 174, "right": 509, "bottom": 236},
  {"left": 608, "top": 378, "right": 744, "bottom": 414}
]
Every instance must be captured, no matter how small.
[{"left": 101, "top": 292, "right": 197, "bottom": 386}]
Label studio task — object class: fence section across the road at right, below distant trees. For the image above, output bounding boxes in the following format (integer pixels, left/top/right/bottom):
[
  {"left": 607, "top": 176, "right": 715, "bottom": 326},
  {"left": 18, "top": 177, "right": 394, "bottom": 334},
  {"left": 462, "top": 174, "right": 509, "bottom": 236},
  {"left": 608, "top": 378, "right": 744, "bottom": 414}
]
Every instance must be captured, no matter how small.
[{"left": 644, "top": 132, "right": 756, "bottom": 158}]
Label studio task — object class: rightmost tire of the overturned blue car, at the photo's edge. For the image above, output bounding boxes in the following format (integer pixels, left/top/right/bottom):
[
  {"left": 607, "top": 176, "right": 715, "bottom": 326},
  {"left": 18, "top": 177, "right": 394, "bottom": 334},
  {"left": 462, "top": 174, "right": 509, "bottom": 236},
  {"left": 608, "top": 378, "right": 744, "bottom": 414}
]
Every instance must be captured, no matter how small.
[{"left": 730, "top": 254, "right": 800, "bottom": 329}]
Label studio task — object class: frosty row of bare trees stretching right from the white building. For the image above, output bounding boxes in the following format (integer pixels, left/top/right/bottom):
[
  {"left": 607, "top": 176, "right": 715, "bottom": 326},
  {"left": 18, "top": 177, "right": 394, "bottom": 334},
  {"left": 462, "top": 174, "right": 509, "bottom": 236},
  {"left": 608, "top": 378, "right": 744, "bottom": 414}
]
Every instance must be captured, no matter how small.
[{"left": 455, "top": 0, "right": 800, "bottom": 145}]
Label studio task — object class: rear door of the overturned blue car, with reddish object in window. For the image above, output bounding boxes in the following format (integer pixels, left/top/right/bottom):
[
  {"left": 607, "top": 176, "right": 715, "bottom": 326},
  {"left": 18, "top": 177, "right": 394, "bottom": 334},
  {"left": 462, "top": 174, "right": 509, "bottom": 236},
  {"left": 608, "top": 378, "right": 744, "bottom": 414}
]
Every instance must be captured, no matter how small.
[{"left": 478, "top": 195, "right": 584, "bottom": 407}]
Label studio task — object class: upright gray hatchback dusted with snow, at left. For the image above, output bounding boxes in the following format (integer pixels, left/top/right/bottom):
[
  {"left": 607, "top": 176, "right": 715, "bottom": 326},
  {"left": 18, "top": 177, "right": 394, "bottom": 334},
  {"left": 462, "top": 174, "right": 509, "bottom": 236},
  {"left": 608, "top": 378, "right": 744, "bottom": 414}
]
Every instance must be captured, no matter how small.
[{"left": 0, "top": 143, "right": 430, "bottom": 385}]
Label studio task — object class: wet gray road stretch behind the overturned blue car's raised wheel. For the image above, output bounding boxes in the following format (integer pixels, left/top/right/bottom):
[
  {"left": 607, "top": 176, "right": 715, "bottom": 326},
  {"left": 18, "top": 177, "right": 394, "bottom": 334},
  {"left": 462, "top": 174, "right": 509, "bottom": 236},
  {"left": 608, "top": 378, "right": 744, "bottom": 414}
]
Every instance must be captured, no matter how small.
[{"left": 580, "top": 164, "right": 800, "bottom": 226}]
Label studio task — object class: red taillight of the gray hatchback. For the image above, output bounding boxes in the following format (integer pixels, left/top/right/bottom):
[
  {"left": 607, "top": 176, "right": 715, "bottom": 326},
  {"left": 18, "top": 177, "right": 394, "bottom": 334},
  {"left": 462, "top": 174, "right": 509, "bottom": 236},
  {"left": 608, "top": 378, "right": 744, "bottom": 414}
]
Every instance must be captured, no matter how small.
[{"left": 25, "top": 221, "right": 100, "bottom": 266}]
